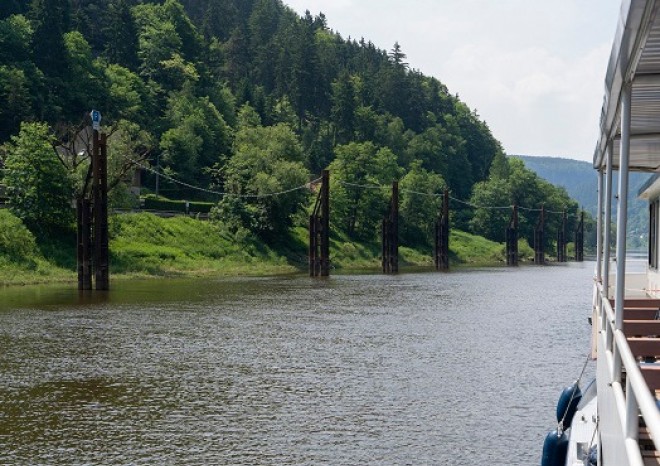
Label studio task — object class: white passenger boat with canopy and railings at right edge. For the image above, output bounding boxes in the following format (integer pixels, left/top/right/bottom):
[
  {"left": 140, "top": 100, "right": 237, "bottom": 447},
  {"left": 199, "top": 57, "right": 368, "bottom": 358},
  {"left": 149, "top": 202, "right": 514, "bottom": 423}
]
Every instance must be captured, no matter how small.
[{"left": 542, "top": 0, "right": 660, "bottom": 466}]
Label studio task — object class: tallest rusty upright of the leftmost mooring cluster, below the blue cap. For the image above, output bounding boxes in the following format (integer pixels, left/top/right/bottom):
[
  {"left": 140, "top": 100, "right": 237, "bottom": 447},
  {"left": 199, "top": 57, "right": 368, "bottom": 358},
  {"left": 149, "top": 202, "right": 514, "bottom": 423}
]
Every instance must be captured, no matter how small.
[{"left": 92, "top": 130, "right": 110, "bottom": 290}]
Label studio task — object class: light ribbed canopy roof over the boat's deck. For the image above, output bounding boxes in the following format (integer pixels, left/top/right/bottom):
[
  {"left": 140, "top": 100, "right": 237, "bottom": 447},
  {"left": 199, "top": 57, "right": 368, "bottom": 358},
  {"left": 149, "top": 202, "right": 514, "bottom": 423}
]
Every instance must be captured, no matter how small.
[{"left": 594, "top": 0, "right": 660, "bottom": 172}]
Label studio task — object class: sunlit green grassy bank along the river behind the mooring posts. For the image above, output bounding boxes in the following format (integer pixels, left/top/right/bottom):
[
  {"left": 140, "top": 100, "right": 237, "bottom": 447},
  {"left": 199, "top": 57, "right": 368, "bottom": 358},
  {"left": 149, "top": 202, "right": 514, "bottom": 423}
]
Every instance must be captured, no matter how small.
[{"left": 0, "top": 210, "right": 510, "bottom": 285}]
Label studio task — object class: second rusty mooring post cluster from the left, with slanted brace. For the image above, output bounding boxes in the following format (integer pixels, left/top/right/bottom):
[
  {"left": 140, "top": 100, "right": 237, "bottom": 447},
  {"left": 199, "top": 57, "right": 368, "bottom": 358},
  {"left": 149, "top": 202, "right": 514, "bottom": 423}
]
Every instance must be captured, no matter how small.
[{"left": 309, "top": 170, "right": 330, "bottom": 277}]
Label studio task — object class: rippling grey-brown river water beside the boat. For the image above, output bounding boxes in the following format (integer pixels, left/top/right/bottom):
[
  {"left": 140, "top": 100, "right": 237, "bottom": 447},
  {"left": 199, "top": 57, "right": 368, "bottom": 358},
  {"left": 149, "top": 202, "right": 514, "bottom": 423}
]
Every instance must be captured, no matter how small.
[{"left": 0, "top": 263, "right": 595, "bottom": 465}]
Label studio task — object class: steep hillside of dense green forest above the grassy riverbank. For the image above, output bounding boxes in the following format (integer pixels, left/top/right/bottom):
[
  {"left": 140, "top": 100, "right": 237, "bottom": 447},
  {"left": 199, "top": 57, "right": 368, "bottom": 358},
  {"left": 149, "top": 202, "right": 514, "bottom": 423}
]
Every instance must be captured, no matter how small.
[{"left": 0, "top": 0, "right": 576, "bottom": 256}]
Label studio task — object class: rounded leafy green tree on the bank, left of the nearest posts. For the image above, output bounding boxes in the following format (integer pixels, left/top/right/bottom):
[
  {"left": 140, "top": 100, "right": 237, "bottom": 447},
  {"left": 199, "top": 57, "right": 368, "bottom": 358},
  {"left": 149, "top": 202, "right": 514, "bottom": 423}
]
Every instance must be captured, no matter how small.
[{"left": 4, "top": 123, "right": 73, "bottom": 233}]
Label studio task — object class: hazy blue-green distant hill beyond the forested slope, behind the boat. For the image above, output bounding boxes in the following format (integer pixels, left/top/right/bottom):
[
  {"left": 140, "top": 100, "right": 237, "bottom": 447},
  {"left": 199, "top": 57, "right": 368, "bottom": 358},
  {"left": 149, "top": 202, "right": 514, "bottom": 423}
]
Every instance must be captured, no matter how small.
[{"left": 511, "top": 155, "right": 652, "bottom": 246}]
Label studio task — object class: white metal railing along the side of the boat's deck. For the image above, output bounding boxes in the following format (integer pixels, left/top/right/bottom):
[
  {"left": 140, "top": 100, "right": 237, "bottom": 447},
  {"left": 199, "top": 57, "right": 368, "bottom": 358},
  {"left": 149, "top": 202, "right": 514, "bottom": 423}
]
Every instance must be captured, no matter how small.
[{"left": 596, "top": 283, "right": 660, "bottom": 465}]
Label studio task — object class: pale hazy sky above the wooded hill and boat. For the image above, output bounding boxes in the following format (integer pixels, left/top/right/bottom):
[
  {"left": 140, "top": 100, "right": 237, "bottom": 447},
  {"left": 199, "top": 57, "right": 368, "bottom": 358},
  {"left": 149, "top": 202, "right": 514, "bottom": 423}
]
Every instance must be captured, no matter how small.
[{"left": 284, "top": 0, "right": 621, "bottom": 161}]
